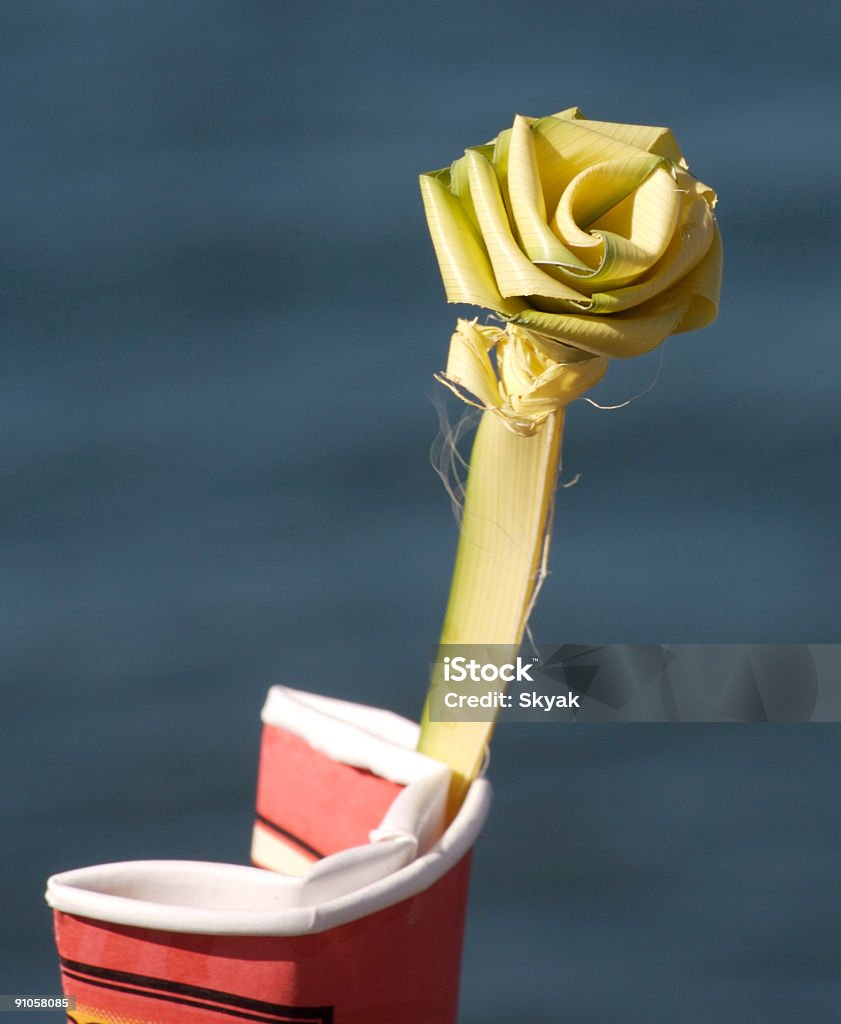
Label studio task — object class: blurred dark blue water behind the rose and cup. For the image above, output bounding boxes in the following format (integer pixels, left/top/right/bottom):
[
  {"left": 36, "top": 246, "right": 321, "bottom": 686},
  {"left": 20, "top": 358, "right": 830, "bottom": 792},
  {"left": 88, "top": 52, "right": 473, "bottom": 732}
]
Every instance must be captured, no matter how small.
[{"left": 0, "top": 0, "right": 841, "bottom": 1024}]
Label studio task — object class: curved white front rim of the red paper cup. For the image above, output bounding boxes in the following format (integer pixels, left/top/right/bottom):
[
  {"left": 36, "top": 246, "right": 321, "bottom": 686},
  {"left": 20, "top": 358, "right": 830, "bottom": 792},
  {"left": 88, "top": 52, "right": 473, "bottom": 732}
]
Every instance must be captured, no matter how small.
[{"left": 46, "top": 779, "right": 492, "bottom": 936}]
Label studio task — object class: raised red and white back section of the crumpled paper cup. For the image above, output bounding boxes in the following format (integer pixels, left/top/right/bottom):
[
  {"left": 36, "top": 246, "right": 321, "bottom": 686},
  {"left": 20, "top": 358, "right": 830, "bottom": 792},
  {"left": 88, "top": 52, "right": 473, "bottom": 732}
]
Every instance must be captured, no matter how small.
[{"left": 251, "top": 686, "right": 458, "bottom": 874}]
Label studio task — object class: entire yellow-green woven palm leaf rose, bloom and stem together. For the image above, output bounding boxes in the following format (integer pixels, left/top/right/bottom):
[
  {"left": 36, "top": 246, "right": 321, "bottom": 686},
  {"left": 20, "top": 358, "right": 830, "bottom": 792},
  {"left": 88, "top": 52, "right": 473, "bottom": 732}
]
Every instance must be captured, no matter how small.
[{"left": 420, "top": 108, "right": 722, "bottom": 798}]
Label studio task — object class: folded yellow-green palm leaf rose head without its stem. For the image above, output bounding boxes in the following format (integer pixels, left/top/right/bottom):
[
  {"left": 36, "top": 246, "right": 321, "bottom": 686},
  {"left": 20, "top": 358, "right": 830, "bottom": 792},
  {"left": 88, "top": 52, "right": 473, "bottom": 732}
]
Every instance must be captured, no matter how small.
[{"left": 420, "top": 108, "right": 721, "bottom": 379}]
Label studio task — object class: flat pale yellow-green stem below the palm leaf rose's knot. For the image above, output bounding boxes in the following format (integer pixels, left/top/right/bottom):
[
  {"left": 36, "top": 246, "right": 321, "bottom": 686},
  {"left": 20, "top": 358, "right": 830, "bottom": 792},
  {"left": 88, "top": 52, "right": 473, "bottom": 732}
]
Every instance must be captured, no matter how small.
[{"left": 418, "top": 409, "right": 563, "bottom": 820}]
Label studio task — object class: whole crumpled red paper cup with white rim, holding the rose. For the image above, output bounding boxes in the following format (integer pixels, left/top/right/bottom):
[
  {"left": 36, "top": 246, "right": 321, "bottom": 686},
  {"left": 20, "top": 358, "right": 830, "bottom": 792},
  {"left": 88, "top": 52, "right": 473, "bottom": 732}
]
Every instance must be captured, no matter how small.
[{"left": 47, "top": 691, "right": 491, "bottom": 1024}]
